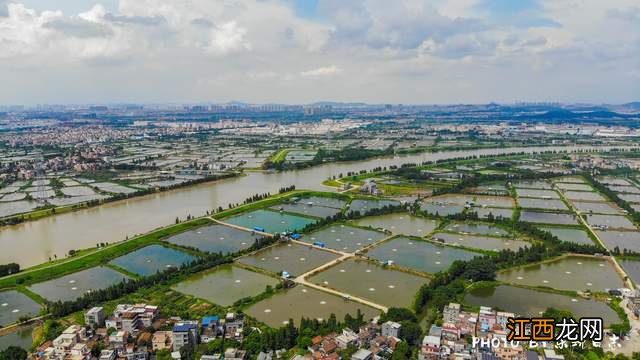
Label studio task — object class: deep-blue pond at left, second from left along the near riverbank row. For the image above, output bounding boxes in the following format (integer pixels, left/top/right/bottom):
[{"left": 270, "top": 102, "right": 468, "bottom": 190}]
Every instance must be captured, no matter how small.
[{"left": 110, "top": 245, "right": 197, "bottom": 276}]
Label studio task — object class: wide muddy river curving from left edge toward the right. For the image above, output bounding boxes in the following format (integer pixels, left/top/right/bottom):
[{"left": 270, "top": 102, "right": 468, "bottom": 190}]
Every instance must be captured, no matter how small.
[{"left": 0, "top": 147, "right": 632, "bottom": 267}]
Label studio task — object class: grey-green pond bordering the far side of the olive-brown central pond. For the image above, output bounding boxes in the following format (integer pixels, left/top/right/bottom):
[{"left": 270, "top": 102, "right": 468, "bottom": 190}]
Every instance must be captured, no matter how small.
[{"left": 366, "top": 237, "right": 480, "bottom": 273}]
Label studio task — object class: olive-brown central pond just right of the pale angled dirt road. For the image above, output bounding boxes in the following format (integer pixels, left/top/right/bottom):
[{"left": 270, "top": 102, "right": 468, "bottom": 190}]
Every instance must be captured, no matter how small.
[{"left": 308, "top": 260, "right": 429, "bottom": 307}]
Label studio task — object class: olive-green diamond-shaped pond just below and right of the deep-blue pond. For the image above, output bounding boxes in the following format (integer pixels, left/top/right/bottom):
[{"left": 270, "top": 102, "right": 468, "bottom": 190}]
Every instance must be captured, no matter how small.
[{"left": 174, "top": 265, "right": 279, "bottom": 306}]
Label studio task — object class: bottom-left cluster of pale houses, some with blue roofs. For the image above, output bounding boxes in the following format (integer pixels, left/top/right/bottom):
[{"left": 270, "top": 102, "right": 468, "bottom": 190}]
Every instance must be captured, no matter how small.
[{"left": 34, "top": 304, "right": 246, "bottom": 360}]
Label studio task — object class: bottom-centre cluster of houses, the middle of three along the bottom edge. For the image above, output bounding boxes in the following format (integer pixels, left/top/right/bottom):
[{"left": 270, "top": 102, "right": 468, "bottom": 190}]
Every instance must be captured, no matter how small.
[{"left": 293, "top": 321, "right": 401, "bottom": 360}]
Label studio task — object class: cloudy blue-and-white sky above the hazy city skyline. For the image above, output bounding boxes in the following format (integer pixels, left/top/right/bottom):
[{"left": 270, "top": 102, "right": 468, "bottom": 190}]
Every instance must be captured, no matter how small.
[{"left": 0, "top": 0, "right": 640, "bottom": 105}]
